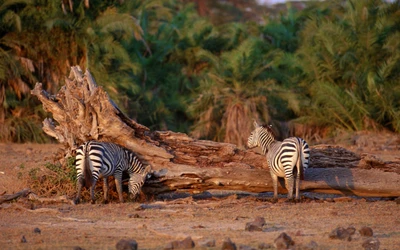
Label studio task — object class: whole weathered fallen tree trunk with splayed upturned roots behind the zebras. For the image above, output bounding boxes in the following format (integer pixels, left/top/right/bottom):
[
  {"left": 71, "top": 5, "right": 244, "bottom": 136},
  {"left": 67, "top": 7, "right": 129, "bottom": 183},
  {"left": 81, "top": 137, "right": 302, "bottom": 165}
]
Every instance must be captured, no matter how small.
[{"left": 31, "top": 67, "right": 400, "bottom": 197}]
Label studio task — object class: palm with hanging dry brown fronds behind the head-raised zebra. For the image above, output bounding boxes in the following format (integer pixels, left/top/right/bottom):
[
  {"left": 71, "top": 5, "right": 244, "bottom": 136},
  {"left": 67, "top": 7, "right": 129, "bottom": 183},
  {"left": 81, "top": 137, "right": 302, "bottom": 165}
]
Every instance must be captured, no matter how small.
[{"left": 189, "top": 38, "right": 290, "bottom": 146}]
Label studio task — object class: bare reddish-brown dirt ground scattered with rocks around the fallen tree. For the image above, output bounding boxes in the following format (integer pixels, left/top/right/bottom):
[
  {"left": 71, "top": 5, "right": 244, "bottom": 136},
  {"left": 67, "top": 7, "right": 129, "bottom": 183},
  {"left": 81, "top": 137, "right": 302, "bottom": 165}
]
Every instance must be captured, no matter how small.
[{"left": 0, "top": 133, "right": 400, "bottom": 249}]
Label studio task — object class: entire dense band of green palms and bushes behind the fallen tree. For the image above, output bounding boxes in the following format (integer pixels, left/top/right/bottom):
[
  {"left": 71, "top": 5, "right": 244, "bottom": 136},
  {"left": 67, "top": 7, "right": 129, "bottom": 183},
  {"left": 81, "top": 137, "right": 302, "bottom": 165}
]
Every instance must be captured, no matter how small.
[{"left": 0, "top": 0, "right": 400, "bottom": 146}]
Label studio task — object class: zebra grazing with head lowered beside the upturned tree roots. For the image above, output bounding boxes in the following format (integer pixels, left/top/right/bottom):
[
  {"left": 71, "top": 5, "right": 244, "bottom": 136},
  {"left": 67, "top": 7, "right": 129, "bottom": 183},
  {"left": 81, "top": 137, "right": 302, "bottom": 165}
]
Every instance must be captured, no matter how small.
[{"left": 74, "top": 141, "right": 151, "bottom": 204}]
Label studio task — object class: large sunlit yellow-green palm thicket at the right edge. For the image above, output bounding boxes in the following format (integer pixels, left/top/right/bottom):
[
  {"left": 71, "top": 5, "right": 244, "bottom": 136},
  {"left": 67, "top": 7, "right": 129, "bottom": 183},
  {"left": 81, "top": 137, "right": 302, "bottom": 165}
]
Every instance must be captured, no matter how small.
[{"left": 297, "top": 0, "right": 400, "bottom": 131}]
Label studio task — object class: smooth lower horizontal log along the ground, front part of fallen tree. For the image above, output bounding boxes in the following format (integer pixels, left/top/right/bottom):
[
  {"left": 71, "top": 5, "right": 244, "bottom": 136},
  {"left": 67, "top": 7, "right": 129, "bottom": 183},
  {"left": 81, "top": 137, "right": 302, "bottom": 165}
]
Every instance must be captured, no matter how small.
[{"left": 144, "top": 165, "right": 400, "bottom": 197}]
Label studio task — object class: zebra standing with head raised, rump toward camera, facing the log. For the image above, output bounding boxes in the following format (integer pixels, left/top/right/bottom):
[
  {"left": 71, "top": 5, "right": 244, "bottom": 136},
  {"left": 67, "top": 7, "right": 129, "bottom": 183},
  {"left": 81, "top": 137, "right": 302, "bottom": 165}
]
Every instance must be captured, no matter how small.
[{"left": 247, "top": 122, "right": 310, "bottom": 200}]
